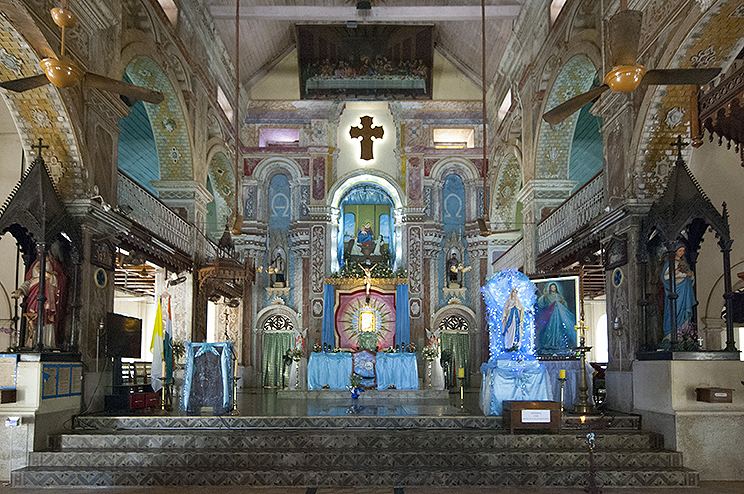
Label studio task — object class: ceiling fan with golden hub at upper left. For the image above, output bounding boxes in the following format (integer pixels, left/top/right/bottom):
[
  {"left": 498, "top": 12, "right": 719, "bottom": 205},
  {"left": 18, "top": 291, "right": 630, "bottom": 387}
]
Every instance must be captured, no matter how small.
[{"left": 0, "top": 1, "right": 163, "bottom": 106}]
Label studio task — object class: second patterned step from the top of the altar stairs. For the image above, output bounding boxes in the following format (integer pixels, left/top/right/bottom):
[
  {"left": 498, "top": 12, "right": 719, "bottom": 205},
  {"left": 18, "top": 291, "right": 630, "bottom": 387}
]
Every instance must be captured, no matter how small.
[{"left": 56, "top": 429, "right": 664, "bottom": 451}]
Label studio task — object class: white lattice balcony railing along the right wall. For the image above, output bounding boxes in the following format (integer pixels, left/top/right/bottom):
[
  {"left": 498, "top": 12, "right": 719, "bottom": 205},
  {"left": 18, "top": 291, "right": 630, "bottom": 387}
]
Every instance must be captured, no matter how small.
[{"left": 537, "top": 172, "right": 605, "bottom": 253}]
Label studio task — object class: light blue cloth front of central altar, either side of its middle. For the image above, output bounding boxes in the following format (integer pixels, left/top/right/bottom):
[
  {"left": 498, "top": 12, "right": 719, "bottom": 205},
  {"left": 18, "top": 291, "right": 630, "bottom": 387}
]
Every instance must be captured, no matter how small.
[{"left": 307, "top": 352, "right": 419, "bottom": 390}]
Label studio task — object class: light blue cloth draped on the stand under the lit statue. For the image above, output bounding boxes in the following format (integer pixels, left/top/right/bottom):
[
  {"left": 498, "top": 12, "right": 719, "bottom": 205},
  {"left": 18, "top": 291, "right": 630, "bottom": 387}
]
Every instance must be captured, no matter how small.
[{"left": 479, "top": 359, "right": 553, "bottom": 415}]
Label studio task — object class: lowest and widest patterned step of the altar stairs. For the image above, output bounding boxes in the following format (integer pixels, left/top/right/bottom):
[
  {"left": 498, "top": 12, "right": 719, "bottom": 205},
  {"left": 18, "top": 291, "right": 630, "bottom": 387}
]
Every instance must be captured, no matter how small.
[{"left": 11, "top": 466, "right": 699, "bottom": 487}]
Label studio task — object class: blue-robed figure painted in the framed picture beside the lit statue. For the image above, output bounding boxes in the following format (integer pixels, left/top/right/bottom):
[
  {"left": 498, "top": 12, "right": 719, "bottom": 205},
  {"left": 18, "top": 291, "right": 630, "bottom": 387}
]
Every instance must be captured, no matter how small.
[{"left": 536, "top": 283, "right": 576, "bottom": 353}]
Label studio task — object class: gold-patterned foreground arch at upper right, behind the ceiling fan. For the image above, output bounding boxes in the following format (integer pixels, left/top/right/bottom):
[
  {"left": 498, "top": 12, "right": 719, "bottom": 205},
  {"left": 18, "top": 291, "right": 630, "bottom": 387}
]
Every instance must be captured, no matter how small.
[{"left": 631, "top": 0, "right": 744, "bottom": 201}]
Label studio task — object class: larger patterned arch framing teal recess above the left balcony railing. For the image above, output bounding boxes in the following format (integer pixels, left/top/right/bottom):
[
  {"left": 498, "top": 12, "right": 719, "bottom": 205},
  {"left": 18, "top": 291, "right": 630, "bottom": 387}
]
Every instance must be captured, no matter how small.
[{"left": 125, "top": 56, "right": 194, "bottom": 181}]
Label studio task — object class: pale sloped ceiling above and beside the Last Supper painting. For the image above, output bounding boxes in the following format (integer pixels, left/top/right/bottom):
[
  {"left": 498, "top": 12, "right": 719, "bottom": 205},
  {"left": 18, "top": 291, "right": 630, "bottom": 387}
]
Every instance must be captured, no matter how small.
[{"left": 204, "top": 0, "right": 528, "bottom": 87}]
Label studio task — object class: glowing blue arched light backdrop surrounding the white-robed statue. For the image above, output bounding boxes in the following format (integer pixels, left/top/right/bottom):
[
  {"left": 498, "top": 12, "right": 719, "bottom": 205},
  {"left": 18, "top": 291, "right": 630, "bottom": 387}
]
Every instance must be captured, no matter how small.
[{"left": 481, "top": 269, "right": 537, "bottom": 361}]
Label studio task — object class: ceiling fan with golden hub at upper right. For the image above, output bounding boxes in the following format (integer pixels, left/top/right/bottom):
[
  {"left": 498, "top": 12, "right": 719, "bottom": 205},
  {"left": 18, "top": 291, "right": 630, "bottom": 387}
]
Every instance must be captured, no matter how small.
[{"left": 543, "top": 9, "right": 721, "bottom": 125}]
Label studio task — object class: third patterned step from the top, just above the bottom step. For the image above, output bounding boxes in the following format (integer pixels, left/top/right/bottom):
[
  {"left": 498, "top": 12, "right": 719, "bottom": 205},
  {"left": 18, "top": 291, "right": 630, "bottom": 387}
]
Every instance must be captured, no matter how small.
[{"left": 29, "top": 449, "right": 682, "bottom": 471}]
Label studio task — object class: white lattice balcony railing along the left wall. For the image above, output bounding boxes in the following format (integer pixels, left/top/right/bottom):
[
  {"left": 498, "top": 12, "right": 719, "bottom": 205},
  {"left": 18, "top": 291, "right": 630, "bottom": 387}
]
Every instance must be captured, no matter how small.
[{"left": 118, "top": 172, "right": 193, "bottom": 252}]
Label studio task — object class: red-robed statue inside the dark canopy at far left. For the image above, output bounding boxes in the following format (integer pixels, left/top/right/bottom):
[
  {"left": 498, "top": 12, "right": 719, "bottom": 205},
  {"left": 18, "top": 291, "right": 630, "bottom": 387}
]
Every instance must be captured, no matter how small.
[{"left": 11, "top": 252, "right": 67, "bottom": 347}]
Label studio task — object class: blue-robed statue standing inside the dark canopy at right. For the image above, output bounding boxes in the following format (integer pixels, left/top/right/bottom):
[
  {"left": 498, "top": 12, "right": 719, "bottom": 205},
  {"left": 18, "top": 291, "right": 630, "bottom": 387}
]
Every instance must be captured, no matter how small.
[{"left": 661, "top": 244, "right": 698, "bottom": 346}]
